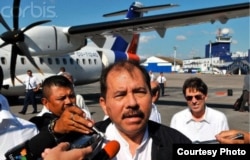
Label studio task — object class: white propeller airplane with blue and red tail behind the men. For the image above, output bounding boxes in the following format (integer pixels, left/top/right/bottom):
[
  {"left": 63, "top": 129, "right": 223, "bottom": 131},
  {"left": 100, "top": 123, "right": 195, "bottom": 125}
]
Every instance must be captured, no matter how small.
[{"left": 0, "top": 0, "right": 249, "bottom": 99}]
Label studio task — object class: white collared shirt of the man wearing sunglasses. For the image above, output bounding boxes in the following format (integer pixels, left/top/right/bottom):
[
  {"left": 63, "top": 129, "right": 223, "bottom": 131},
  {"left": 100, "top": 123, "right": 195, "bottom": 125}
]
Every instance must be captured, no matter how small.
[{"left": 170, "top": 106, "right": 229, "bottom": 142}]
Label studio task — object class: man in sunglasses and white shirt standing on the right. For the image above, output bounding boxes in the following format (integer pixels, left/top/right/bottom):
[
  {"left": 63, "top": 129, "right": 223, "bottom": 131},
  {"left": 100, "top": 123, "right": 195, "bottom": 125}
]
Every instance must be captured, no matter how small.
[{"left": 170, "top": 77, "right": 229, "bottom": 142}]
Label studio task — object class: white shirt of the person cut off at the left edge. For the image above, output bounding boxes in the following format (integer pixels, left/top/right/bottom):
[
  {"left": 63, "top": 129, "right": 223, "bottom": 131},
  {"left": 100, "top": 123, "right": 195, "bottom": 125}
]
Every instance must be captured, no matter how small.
[{"left": 0, "top": 94, "right": 38, "bottom": 160}]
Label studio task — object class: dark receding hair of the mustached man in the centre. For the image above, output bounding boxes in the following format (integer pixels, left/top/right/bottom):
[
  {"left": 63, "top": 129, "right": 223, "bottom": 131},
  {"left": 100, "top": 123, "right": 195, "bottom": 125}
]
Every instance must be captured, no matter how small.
[{"left": 100, "top": 60, "right": 151, "bottom": 98}]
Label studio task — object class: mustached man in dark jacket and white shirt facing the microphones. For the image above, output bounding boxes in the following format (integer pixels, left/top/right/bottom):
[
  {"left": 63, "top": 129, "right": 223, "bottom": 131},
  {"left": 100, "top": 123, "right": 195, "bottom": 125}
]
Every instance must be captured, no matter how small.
[{"left": 95, "top": 61, "right": 191, "bottom": 160}]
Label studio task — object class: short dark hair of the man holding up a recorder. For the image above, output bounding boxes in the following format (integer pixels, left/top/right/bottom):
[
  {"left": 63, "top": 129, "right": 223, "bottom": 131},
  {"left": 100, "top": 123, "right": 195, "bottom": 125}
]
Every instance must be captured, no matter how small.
[{"left": 42, "top": 75, "right": 73, "bottom": 98}]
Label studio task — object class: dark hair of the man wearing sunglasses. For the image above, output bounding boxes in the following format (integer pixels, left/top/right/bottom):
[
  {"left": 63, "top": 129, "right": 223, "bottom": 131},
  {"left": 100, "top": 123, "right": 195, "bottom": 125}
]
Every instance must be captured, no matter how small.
[{"left": 182, "top": 77, "right": 207, "bottom": 95}]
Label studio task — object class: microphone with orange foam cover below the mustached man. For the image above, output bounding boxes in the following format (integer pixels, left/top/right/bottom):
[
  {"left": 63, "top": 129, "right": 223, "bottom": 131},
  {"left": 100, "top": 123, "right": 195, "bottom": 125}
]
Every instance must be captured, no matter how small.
[{"left": 91, "top": 140, "right": 120, "bottom": 160}]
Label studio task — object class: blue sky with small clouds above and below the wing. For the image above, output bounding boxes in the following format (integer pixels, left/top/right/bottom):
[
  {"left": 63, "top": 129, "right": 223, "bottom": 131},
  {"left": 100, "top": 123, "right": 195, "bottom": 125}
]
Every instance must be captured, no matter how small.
[{"left": 0, "top": 0, "right": 250, "bottom": 59}]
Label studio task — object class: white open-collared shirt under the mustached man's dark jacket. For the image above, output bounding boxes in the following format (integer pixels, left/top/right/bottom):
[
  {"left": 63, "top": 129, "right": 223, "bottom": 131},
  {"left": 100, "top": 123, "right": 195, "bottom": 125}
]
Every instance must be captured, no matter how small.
[{"left": 104, "top": 123, "right": 152, "bottom": 160}]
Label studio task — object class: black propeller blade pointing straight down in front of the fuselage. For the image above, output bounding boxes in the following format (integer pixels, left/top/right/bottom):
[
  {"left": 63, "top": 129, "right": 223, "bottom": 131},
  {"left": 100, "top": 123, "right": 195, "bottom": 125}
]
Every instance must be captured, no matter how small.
[{"left": 10, "top": 45, "right": 19, "bottom": 86}]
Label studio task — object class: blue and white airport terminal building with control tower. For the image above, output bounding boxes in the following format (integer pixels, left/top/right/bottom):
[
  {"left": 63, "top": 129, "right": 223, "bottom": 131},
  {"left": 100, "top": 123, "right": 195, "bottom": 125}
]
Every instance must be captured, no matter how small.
[{"left": 183, "top": 28, "right": 250, "bottom": 74}]
